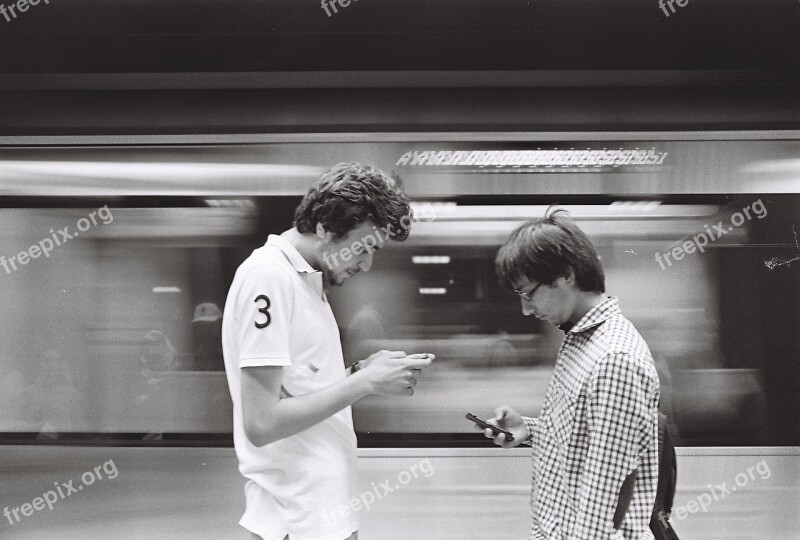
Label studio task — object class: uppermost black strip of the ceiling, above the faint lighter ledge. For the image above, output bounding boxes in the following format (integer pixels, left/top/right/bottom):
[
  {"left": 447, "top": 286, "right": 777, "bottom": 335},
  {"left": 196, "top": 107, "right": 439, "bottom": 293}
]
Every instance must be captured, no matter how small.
[{"left": 0, "top": 0, "right": 800, "bottom": 82}]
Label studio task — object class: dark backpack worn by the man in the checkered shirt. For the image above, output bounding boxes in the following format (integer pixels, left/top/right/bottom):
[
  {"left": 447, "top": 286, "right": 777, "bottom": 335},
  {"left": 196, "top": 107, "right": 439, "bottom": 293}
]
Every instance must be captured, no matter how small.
[{"left": 614, "top": 412, "right": 679, "bottom": 540}]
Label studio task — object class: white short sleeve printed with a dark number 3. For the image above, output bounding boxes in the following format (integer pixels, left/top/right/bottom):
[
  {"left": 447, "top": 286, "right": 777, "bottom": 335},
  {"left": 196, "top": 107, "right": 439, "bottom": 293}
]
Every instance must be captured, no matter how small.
[{"left": 235, "top": 264, "right": 293, "bottom": 368}]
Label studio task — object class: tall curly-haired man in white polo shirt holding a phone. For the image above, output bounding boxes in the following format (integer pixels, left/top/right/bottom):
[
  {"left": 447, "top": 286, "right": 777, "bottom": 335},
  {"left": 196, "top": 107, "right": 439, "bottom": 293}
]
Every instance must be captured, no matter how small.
[{"left": 222, "top": 164, "right": 433, "bottom": 540}]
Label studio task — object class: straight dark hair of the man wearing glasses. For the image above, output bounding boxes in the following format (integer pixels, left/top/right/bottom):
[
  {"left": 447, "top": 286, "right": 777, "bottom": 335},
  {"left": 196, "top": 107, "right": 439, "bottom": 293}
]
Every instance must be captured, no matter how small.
[{"left": 495, "top": 207, "right": 606, "bottom": 293}]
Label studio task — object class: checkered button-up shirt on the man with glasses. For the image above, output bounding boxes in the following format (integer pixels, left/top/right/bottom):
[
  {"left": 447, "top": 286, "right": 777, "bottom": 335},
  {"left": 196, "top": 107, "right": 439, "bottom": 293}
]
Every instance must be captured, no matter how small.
[{"left": 524, "top": 297, "right": 659, "bottom": 540}]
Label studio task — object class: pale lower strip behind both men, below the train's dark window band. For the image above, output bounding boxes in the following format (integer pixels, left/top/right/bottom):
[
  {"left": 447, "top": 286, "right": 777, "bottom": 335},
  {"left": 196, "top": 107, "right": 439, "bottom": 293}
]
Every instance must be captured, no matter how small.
[{"left": 0, "top": 446, "right": 800, "bottom": 540}]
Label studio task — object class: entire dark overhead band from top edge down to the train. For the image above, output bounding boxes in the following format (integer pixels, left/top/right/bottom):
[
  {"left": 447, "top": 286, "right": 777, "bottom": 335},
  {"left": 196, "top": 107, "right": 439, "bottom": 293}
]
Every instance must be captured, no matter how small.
[{"left": 0, "top": 0, "right": 800, "bottom": 136}]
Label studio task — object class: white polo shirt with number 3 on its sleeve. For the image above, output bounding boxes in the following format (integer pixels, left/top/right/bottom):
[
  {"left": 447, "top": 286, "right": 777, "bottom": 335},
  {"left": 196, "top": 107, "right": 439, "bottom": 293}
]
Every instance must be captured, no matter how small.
[{"left": 222, "top": 235, "right": 358, "bottom": 540}]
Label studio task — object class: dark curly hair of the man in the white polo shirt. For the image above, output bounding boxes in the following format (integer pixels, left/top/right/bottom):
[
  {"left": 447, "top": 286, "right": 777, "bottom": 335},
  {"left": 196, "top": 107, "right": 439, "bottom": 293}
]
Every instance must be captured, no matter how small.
[{"left": 294, "top": 163, "right": 413, "bottom": 242}]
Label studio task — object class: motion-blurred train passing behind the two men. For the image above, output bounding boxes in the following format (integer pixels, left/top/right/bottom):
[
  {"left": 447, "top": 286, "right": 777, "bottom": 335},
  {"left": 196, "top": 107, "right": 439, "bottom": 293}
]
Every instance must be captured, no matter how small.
[{"left": 0, "top": 133, "right": 800, "bottom": 540}]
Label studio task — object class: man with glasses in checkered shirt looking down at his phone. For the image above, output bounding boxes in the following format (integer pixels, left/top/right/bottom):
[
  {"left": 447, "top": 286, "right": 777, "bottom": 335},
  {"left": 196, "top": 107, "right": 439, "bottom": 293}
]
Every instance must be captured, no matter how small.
[{"left": 478, "top": 211, "right": 659, "bottom": 540}]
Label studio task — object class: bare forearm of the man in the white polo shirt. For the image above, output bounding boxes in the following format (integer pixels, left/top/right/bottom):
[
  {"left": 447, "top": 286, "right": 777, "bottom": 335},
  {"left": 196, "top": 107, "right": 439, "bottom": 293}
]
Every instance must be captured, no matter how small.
[{"left": 248, "top": 372, "right": 372, "bottom": 446}]
